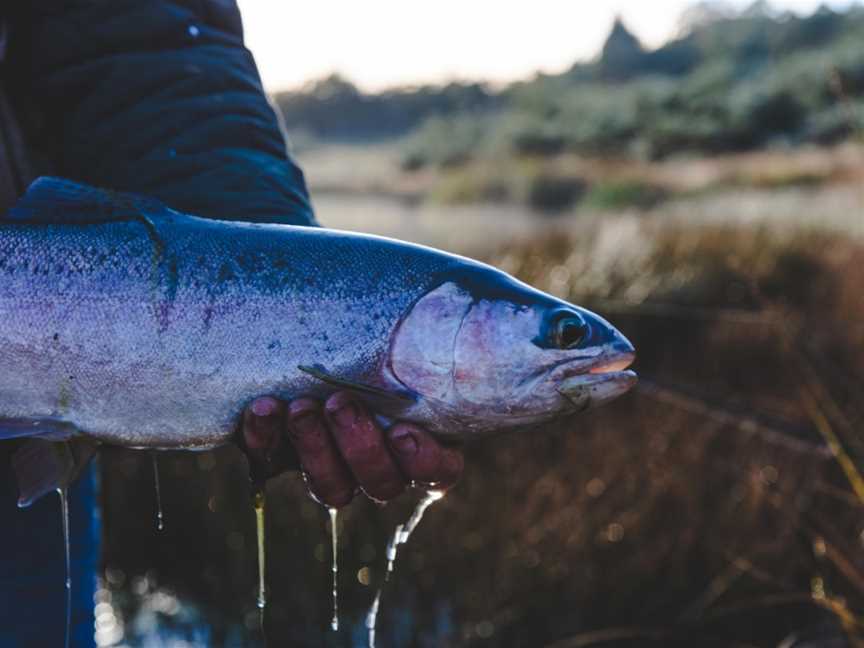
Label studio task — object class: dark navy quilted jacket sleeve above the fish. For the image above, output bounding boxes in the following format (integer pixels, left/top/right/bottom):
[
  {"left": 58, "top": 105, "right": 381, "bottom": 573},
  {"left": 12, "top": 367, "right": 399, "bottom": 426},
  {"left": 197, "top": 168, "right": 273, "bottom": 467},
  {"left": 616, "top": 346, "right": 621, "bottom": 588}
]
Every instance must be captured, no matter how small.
[{"left": 7, "top": 0, "right": 315, "bottom": 225}]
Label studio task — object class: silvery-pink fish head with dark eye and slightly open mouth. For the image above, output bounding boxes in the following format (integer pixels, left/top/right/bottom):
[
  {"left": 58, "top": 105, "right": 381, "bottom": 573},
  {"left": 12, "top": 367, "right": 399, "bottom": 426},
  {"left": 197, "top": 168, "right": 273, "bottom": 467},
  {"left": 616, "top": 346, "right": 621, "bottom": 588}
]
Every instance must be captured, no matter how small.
[{"left": 389, "top": 267, "right": 636, "bottom": 431}]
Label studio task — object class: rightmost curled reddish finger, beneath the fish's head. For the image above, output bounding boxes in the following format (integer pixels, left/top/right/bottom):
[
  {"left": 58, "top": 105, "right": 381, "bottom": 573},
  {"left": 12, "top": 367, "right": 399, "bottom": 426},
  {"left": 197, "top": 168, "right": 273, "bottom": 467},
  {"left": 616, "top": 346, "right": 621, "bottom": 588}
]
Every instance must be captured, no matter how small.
[{"left": 387, "top": 423, "right": 465, "bottom": 489}]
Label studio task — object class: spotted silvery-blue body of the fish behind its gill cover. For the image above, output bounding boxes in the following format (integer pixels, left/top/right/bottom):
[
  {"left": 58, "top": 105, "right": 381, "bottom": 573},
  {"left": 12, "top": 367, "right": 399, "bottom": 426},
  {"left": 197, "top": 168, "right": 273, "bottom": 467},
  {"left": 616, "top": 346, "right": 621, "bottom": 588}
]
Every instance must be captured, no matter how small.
[{"left": 0, "top": 178, "right": 636, "bottom": 448}]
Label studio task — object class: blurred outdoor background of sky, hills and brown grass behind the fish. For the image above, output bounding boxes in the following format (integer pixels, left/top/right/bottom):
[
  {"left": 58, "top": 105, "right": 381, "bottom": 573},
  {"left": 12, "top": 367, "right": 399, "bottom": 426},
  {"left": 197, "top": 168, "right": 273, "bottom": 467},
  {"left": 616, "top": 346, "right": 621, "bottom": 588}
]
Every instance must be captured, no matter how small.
[{"left": 97, "top": 0, "right": 864, "bottom": 648}]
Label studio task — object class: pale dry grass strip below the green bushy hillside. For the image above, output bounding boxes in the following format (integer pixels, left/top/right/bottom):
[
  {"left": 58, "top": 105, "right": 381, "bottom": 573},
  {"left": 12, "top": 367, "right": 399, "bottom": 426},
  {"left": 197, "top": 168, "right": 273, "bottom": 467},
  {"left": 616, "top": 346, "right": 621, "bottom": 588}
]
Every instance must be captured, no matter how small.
[{"left": 298, "top": 141, "right": 864, "bottom": 206}]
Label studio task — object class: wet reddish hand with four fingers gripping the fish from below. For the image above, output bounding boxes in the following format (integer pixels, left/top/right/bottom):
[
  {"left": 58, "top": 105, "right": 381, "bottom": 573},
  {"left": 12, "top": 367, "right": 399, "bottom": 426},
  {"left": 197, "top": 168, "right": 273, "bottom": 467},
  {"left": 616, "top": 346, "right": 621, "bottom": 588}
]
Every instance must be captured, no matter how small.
[{"left": 241, "top": 391, "right": 463, "bottom": 508}]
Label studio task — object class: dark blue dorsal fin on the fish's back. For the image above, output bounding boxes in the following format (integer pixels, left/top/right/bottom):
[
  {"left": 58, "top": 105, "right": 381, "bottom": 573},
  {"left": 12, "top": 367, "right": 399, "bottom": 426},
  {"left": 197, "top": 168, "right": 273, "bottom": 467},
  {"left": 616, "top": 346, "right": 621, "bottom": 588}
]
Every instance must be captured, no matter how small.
[{"left": 4, "top": 176, "right": 170, "bottom": 225}]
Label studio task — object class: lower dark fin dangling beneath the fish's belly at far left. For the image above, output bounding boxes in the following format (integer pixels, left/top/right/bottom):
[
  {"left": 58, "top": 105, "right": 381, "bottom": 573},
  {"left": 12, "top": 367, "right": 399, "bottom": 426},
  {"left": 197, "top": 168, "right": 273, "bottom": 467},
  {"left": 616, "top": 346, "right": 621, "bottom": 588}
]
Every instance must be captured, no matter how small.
[{"left": 12, "top": 438, "right": 98, "bottom": 508}]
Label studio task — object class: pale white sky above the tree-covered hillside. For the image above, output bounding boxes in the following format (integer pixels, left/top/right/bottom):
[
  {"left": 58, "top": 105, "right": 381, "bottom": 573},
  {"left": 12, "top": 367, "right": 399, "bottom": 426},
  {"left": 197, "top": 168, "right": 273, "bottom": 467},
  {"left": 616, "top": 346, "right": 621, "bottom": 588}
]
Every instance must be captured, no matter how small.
[{"left": 239, "top": 0, "right": 851, "bottom": 92}]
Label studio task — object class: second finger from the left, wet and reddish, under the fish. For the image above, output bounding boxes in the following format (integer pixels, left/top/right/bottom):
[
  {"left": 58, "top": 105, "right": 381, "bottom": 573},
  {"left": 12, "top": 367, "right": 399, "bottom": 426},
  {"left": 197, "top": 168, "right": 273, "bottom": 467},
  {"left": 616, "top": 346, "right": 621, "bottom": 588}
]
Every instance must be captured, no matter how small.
[{"left": 286, "top": 398, "right": 354, "bottom": 508}]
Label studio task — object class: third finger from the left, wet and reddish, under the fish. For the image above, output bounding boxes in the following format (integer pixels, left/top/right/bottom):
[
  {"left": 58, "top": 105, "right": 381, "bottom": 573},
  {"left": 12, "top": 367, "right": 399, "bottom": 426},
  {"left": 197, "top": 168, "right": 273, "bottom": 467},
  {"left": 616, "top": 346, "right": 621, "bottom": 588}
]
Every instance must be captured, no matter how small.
[{"left": 324, "top": 392, "right": 405, "bottom": 502}]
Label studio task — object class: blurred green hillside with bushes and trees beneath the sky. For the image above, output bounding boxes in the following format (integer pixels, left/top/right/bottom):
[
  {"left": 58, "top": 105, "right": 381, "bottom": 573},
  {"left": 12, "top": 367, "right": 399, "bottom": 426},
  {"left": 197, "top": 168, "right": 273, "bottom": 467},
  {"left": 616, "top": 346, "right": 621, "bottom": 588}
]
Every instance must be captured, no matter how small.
[{"left": 275, "top": 2, "right": 864, "bottom": 160}]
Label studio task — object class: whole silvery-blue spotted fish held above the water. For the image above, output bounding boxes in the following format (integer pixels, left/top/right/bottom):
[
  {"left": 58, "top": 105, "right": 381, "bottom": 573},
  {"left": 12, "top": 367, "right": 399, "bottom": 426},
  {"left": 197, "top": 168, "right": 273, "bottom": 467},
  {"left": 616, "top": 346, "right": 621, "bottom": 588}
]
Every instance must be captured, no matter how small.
[{"left": 0, "top": 177, "right": 636, "bottom": 503}]
